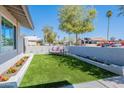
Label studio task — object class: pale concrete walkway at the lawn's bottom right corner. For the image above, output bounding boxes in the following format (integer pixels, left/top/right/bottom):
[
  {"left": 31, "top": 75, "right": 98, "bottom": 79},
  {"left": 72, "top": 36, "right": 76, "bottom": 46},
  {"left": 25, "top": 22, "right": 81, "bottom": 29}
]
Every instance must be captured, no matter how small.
[{"left": 73, "top": 76, "right": 124, "bottom": 88}]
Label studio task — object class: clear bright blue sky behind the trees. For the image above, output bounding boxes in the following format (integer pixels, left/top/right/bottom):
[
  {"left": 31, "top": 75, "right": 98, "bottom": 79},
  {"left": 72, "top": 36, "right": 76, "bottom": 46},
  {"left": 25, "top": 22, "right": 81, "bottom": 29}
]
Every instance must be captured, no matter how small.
[{"left": 21, "top": 5, "right": 124, "bottom": 39}]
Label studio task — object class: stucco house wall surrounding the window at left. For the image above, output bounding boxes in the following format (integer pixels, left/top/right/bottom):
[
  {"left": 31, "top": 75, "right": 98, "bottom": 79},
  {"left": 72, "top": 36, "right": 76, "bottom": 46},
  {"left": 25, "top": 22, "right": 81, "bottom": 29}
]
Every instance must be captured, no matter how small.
[{"left": 0, "top": 6, "right": 23, "bottom": 64}]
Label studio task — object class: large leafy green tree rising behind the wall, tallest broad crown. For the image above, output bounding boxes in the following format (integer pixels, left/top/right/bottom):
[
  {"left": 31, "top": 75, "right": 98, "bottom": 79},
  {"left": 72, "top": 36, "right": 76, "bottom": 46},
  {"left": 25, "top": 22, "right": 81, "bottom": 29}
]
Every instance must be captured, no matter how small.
[{"left": 58, "top": 5, "right": 96, "bottom": 44}]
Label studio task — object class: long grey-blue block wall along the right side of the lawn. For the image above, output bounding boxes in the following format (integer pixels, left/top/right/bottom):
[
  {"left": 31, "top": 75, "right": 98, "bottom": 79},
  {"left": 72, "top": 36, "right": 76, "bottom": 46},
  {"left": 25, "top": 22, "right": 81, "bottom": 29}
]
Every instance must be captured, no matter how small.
[{"left": 66, "top": 46, "right": 124, "bottom": 66}]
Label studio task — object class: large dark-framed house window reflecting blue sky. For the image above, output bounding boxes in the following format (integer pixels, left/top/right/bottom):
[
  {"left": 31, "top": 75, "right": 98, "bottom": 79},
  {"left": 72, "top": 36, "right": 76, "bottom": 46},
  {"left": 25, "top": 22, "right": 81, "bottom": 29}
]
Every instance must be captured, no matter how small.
[{"left": 1, "top": 17, "right": 16, "bottom": 53}]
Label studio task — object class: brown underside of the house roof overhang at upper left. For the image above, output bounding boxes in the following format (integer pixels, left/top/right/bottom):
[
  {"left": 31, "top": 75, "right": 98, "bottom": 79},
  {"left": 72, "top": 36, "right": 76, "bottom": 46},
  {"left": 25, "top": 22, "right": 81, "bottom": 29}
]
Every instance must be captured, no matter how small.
[{"left": 4, "top": 5, "right": 34, "bottom": 29}]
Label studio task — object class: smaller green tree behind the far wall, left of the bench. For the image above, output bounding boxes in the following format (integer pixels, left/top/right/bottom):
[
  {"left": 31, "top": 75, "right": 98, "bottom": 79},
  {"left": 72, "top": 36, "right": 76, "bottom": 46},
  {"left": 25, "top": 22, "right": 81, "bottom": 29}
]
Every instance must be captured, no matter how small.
[{"left": 42, "top": 26, "right": 57, "bottom": 45}]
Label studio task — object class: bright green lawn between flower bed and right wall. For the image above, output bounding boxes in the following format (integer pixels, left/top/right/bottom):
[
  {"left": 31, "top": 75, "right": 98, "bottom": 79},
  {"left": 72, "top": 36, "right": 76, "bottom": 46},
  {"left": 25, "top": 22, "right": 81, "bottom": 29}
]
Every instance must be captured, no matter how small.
[{"left": 20, "top": 55, "right": 115, "bottom": 87}]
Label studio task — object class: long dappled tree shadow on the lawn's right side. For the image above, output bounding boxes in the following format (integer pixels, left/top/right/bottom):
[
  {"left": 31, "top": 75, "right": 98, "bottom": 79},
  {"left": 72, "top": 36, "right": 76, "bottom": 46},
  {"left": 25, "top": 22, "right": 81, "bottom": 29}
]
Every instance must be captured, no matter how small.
[{"left": 50, "top": 55, "right": 117, "bottom": 79}]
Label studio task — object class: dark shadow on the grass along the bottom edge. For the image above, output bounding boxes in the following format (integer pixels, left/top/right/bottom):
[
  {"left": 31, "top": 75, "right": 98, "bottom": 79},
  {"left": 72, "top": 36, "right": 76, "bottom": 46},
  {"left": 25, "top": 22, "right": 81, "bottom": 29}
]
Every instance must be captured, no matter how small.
[{"left": 20, "top": 80, "right": 73, "bottom": 88}]
